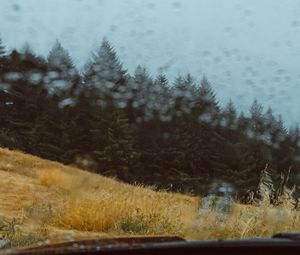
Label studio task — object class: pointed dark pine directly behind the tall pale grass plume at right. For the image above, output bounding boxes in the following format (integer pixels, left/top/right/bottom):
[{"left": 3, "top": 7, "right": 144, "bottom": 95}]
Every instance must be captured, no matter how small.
[{"left": 235, "top": 100, "right": 273, "bottom": 192}]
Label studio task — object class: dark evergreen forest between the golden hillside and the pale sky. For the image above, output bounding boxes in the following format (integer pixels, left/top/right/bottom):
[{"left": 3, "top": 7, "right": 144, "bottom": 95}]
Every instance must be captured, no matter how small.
[{"left": 0, "top": 36, "right": 300, "bottom": 197}]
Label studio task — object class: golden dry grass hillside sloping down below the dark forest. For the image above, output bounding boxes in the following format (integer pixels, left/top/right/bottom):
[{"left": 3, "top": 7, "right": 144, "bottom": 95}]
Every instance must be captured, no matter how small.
[{"left": 0, "top": 149, "right": 300, "bottom": 249}]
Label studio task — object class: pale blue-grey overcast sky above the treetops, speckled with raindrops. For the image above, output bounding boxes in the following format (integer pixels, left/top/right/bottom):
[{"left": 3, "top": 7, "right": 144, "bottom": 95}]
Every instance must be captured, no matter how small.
[{"left": 0, "top": 0, "right": 300, "bottom": 123}]
